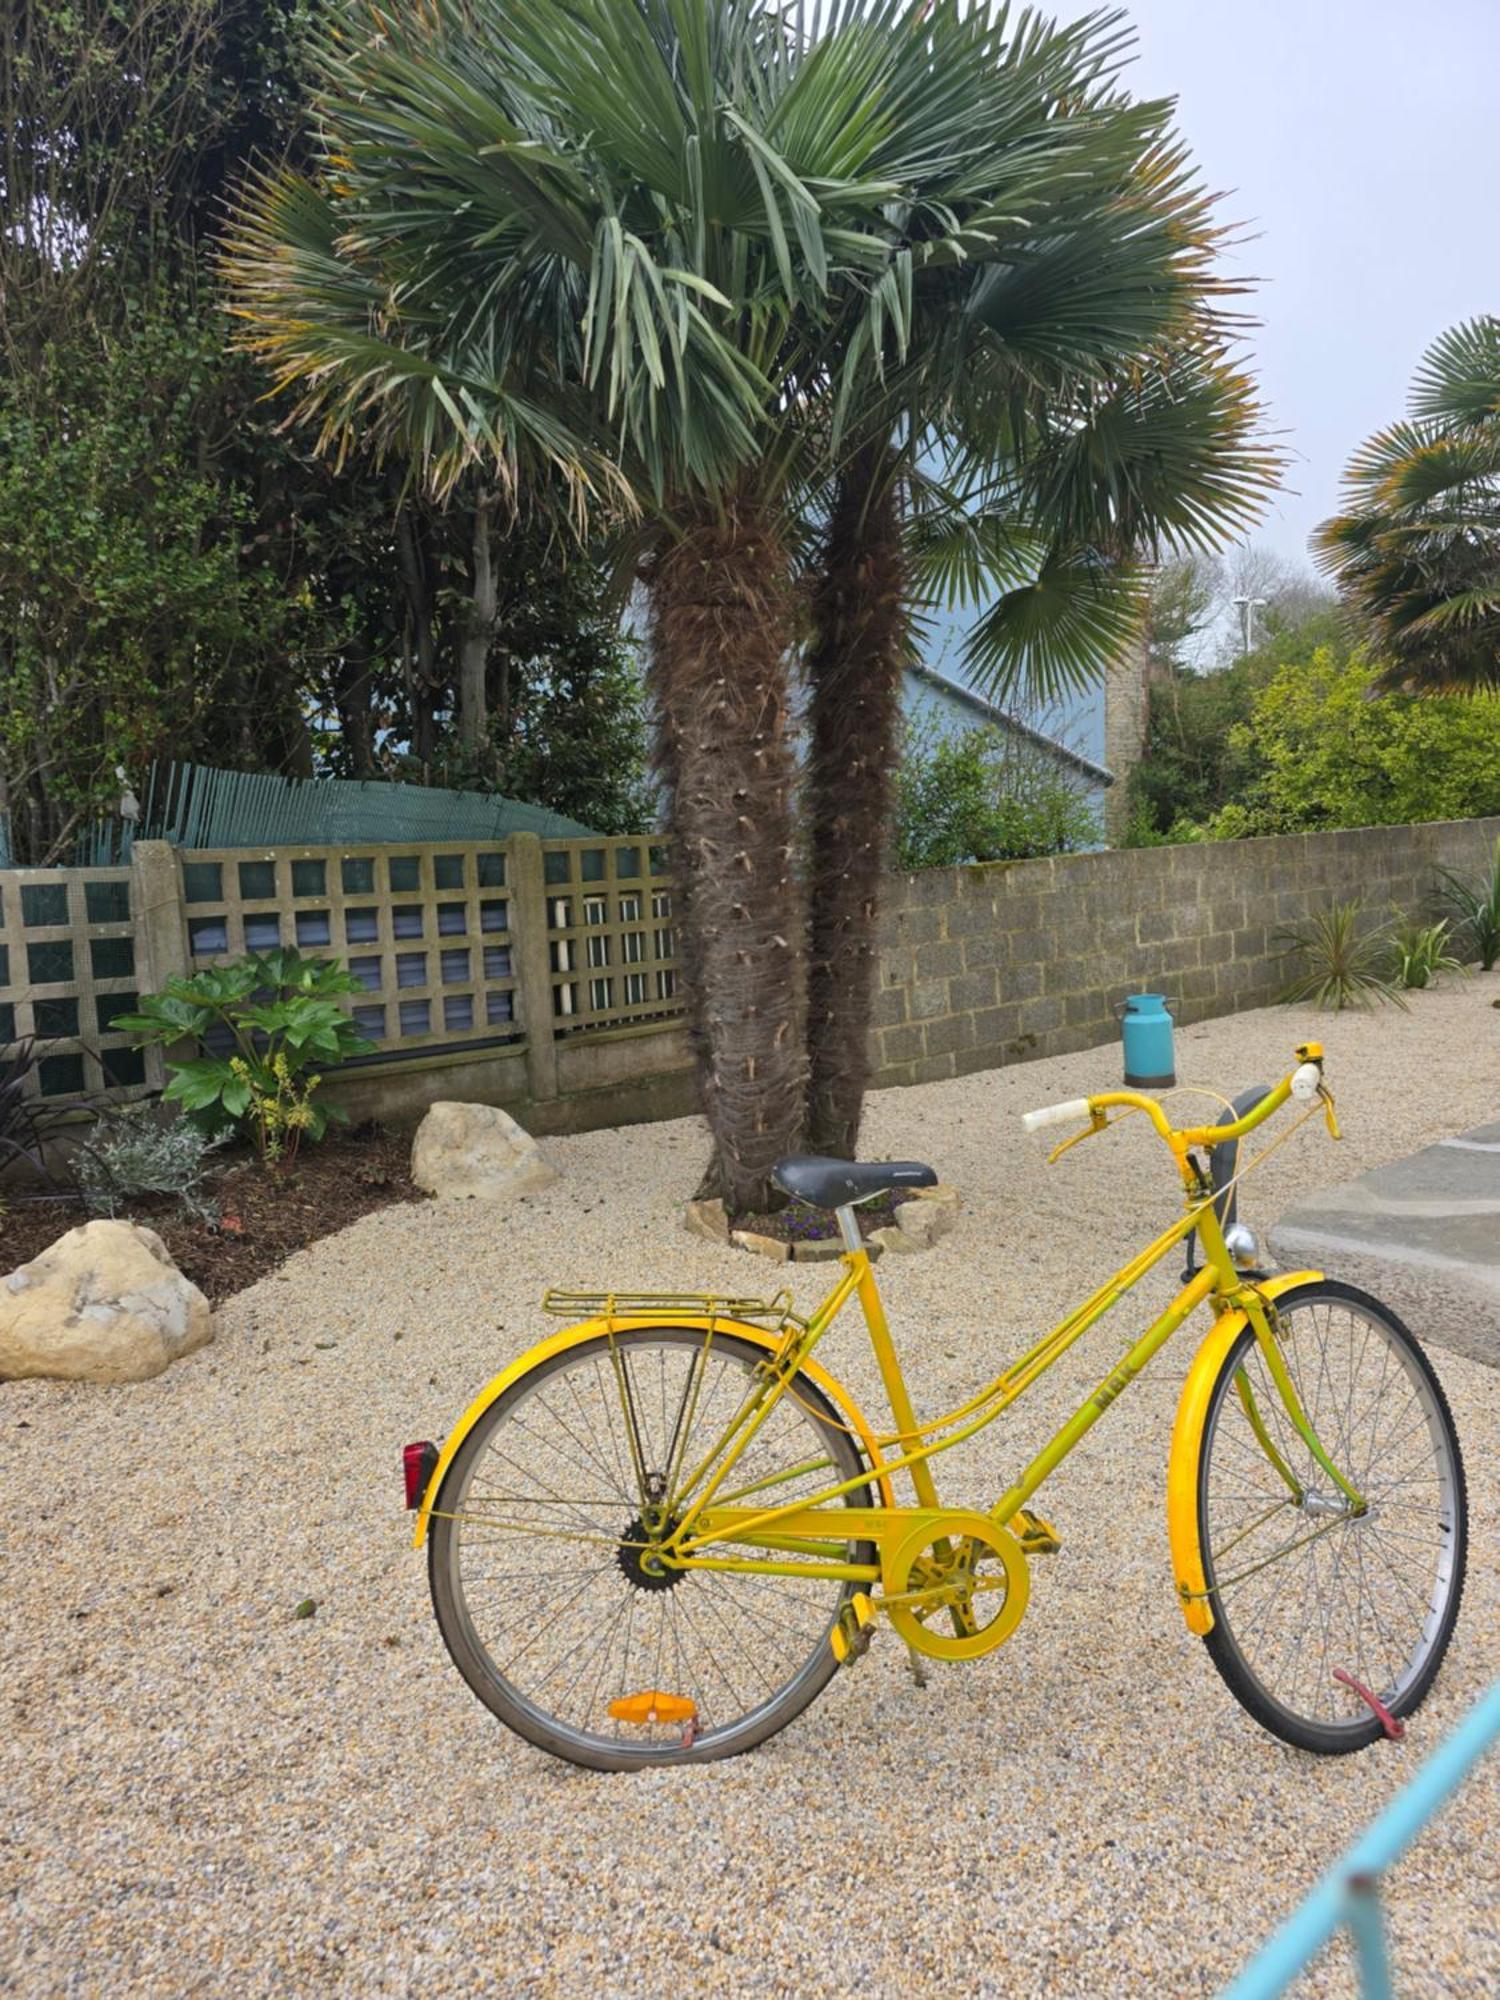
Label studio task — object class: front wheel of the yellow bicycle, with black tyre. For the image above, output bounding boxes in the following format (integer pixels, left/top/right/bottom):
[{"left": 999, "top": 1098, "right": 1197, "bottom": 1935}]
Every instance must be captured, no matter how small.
[{"left": 1198, "top": 1280, "right": 1468, "bottom": 1756}]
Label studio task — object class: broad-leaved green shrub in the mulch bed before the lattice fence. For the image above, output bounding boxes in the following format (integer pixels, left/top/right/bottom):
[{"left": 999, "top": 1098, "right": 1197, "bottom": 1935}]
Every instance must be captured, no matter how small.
[{"left": 116, "top": 950, "right": 374, "bottom": 1162}]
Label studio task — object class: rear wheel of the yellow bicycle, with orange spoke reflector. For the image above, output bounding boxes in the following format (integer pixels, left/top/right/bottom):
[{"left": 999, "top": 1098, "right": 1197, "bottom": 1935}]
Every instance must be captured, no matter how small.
[{"left": 430, "top": 1326, "right": 876, "bottom": 1770}]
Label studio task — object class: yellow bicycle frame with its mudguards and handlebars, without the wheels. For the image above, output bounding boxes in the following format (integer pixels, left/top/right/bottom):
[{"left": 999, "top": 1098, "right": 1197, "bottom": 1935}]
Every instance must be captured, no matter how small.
[{"left": 414, "top": 1044, "right": 1364, "bottom": 1632}]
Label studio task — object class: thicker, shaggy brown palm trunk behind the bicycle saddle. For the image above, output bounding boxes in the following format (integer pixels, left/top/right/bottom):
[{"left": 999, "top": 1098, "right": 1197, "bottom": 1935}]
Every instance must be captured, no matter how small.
[{"left": 650, "top": 494, "right": 806, "bottom": 1214}]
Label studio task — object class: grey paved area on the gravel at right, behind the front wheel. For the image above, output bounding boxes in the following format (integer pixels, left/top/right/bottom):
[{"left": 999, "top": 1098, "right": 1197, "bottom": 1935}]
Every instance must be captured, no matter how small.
[{"left": 1270, "top": 1118, "right": 1500, "bottom": 1368}]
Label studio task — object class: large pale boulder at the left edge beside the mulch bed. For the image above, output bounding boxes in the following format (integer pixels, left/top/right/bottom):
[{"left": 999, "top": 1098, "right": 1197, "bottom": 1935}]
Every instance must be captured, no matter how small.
[{"left": 0, "top": 1222, "right": 214, "bottom": 1382}]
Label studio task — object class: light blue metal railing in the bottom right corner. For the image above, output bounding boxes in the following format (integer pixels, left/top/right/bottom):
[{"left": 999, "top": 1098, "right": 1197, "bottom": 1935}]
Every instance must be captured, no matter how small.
[{"left": 1222, "top": 1680, "right": 1500, "bottom": 2000}]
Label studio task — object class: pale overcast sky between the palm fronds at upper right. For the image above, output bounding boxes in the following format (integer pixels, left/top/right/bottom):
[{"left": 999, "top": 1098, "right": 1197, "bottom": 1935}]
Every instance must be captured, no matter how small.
[{"left": 1104, "top": 0, "right": 1500, "bottom": 562}]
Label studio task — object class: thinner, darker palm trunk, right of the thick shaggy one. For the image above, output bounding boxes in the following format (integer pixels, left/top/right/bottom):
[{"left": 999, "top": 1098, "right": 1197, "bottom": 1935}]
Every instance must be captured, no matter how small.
[{"left": 806, "top": 446, "right": 908, "bottom": 1160}]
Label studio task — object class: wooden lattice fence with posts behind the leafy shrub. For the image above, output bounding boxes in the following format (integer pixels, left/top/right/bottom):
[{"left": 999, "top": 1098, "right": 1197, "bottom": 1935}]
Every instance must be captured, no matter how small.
[{"left": 0, "top": 832, "right": 682, "bottom": 1100}]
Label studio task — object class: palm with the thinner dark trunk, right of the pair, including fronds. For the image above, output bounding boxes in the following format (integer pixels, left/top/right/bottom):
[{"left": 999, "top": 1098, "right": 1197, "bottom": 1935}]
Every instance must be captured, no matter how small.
[{"left": 806, "top": 6, "right": 1276, "bottom": 1156}]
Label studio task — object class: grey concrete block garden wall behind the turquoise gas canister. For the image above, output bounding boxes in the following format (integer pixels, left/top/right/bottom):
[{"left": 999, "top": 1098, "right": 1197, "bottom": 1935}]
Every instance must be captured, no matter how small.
[{"left": 872, "top": 820, "right": 1500, "bottom": 1084}]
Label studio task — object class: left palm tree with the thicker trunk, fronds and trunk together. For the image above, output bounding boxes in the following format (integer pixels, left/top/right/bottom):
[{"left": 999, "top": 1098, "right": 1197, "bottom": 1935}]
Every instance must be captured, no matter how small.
[{"left": 230, "top": 0, "right": 940, "bottom": 1208}]
